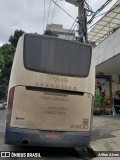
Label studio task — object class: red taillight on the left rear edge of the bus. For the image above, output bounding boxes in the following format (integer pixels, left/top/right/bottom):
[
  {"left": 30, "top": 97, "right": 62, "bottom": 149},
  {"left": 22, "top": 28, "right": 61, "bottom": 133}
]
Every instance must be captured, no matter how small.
[{"left": 8, "top": 87, "right": 15, "bottom": 110}]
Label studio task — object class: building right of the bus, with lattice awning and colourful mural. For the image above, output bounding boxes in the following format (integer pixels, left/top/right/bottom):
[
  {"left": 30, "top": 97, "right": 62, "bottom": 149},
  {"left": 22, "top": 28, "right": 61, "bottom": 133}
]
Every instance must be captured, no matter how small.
[{"left": 88, "top": 0, "right": 120, "bottom": 112}]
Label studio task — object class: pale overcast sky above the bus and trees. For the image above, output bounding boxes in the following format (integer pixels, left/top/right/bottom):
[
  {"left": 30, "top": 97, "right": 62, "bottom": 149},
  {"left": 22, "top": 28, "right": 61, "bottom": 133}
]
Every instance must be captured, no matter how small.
[{"left": 0, "top": 0, "right": 117, "bottom": 46}]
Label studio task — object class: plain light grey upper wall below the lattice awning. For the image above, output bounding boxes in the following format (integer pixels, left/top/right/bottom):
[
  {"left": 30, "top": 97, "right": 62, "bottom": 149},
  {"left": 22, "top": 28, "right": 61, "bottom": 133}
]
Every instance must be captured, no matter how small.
[{"left": 93, "top": 29, "right": 120, "bottom": 65}]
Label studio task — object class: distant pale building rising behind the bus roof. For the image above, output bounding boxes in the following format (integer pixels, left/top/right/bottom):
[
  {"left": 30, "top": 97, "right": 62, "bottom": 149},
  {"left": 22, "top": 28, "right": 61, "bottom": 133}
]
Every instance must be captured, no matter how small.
[{"left": 46, "top": 24, "right": 75, "bottom": 40}]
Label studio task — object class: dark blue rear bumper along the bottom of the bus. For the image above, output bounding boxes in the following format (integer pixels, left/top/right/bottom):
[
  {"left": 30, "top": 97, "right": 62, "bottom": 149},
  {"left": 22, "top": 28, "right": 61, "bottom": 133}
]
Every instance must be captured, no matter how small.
[{"left": 5, "top": 125, "right": 90, "bottom": 147}]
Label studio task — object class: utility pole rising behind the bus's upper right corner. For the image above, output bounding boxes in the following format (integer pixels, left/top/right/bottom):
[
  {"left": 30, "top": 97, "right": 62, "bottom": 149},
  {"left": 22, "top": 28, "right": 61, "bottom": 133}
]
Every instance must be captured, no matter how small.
[{"left": 65, "top": 0, "right": 88, "bottom": 43}]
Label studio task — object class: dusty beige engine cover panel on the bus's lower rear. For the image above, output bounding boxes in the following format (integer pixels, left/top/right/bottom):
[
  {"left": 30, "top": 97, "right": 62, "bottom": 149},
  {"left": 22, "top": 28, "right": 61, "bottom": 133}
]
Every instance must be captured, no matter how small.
[{"left": 10, "top": 86, "right": 92, "bottom": 131}]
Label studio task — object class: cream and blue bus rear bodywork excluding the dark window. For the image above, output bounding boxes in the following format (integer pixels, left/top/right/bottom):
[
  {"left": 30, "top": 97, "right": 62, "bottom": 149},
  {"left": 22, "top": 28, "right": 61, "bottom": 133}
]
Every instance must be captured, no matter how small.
[{"left": 5, "top": 35, "right": 95, "bottom": 147}]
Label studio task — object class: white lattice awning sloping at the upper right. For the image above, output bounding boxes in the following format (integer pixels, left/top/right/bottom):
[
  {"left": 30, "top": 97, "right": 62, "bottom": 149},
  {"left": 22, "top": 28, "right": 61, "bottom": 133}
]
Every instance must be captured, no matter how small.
[{"left": 88, "top": 0, "right": 120, "bottom": 44}]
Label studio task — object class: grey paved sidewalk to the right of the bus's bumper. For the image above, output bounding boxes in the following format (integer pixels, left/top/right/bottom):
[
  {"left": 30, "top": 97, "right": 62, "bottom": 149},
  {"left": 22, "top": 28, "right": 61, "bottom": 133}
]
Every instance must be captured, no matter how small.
[{"left": 90, "top": 115, "right": 120, "bottom": 151}]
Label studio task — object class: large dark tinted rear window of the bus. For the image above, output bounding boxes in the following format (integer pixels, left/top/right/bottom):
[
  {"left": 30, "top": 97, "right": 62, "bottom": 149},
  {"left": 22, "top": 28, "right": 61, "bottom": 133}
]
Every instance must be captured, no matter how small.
[{"left": 24, "top": 34, "right": 92, "bottom": 77}]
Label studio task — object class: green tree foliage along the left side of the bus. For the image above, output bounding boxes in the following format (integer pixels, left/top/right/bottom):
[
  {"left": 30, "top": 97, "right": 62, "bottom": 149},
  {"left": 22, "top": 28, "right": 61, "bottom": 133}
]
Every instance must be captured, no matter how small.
[{"left": 0, "top": 30, "right": 24, "bottom": 100}]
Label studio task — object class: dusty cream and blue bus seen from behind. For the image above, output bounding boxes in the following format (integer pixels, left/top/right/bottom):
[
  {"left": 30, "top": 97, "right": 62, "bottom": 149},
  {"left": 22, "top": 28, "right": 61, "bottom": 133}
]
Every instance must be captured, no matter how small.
[{"left": 5, "top": 34, "right": 95, "bottom": 147}]
